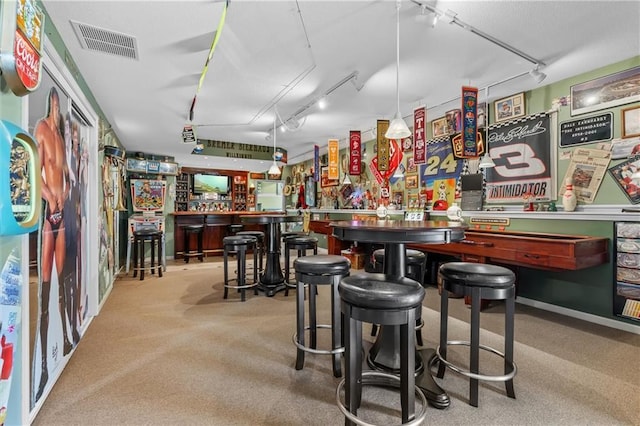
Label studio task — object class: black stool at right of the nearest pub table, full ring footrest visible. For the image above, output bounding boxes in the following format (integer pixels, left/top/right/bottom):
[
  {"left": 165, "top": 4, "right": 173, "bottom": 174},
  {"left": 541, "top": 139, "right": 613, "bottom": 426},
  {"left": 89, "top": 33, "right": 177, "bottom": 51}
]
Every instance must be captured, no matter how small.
[{"left": 436, "top": 262, "right": 517, "bottom": 407}]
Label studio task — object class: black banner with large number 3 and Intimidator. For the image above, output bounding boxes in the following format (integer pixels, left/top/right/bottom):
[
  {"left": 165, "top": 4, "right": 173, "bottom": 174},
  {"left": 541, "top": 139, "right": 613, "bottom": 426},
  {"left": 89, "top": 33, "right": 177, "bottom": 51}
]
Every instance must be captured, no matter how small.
[{"left": 485, "top": 113, "right": 556, "bottom": 203}]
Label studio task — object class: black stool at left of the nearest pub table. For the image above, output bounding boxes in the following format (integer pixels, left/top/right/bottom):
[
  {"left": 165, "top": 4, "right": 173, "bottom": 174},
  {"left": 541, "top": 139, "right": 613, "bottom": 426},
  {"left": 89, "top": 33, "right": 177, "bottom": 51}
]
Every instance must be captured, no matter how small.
[{"left": 293, "top": 255, "right": 351, "bottom": 377}]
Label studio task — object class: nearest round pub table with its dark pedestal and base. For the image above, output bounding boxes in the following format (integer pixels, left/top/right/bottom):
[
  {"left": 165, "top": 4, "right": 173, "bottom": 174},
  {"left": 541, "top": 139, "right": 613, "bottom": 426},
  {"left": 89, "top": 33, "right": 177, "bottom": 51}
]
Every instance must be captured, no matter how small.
[{"left": 329, "top": 220, "right": 467, "bottom": 408}]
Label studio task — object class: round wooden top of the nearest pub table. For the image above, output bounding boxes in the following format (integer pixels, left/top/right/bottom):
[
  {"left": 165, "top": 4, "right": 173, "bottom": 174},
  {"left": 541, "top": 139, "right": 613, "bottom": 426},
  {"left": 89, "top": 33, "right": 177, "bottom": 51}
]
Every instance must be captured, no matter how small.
[{"left": 329, "top": 220, "right": 468, "bottom": 244}]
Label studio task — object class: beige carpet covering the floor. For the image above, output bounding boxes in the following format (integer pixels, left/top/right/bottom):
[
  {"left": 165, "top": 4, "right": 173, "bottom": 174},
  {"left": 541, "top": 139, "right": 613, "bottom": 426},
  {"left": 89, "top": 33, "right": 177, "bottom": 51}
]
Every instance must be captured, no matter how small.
[{"left": 33, "top": 258, "right": 640, "bottom": 426}]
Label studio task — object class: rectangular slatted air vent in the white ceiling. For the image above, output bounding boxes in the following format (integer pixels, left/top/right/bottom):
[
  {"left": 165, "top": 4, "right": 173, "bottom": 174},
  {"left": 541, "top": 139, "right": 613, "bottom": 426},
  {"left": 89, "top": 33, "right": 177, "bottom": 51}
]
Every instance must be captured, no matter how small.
[{"left": 70, "top": 21, "right": 138, "bottom": 60}]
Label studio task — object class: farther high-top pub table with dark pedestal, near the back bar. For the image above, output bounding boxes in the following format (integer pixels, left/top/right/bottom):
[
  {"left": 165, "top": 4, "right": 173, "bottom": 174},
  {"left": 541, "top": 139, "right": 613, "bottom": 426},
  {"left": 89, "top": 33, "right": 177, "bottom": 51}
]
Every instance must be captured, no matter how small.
[{"left": 240, "top": 214, "right": 303, "bottom": 297}]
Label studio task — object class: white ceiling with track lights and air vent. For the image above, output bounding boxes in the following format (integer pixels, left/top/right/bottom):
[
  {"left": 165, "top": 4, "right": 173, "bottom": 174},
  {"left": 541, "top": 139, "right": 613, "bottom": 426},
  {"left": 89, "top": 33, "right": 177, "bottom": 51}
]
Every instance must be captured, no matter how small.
[{"left": 43, "top": 0, "right": 640, "bottom": 171}]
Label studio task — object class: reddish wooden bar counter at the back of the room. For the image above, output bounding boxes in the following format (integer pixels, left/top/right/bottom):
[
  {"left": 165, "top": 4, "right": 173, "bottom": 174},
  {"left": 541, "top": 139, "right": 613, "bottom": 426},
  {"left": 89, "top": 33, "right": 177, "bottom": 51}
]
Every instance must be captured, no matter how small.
[{"left": 171, "top": 211, "right": 285, "bottom": 259}]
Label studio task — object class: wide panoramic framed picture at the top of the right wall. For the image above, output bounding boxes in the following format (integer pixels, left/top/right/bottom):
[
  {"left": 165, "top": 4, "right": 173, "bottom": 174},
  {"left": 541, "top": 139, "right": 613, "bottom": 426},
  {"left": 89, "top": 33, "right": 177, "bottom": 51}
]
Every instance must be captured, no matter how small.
[{"left": 571, "top": 66, "right": 640, "bottom": 115}]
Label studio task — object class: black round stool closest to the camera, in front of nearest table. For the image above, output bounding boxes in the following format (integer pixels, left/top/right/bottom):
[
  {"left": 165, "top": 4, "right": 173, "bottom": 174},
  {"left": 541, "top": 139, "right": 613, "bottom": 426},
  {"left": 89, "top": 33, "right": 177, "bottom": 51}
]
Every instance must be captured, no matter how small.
[{"left": 336, "top": 273, "right": 427, "bottom": 425}]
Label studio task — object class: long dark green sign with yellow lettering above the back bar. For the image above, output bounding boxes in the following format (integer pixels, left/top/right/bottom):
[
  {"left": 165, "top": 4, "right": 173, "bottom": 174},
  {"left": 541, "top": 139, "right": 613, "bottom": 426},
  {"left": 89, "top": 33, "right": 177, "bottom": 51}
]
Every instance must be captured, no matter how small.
[{"left": 191, "top": 139, "right": 287, "bottom": 164}]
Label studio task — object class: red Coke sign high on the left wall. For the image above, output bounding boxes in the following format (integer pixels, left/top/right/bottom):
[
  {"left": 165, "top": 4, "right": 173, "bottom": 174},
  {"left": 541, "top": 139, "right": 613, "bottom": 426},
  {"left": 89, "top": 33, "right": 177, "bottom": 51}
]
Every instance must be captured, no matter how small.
[{"left": 0, "top": 0, "right": 44, "bottom": 96}]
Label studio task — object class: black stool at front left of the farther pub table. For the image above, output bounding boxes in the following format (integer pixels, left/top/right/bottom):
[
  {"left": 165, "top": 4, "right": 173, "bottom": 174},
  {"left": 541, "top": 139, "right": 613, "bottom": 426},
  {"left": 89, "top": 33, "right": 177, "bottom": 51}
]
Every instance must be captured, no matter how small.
[{"left": 222, "top": 235, "right": 258, "bottom": 302}]
